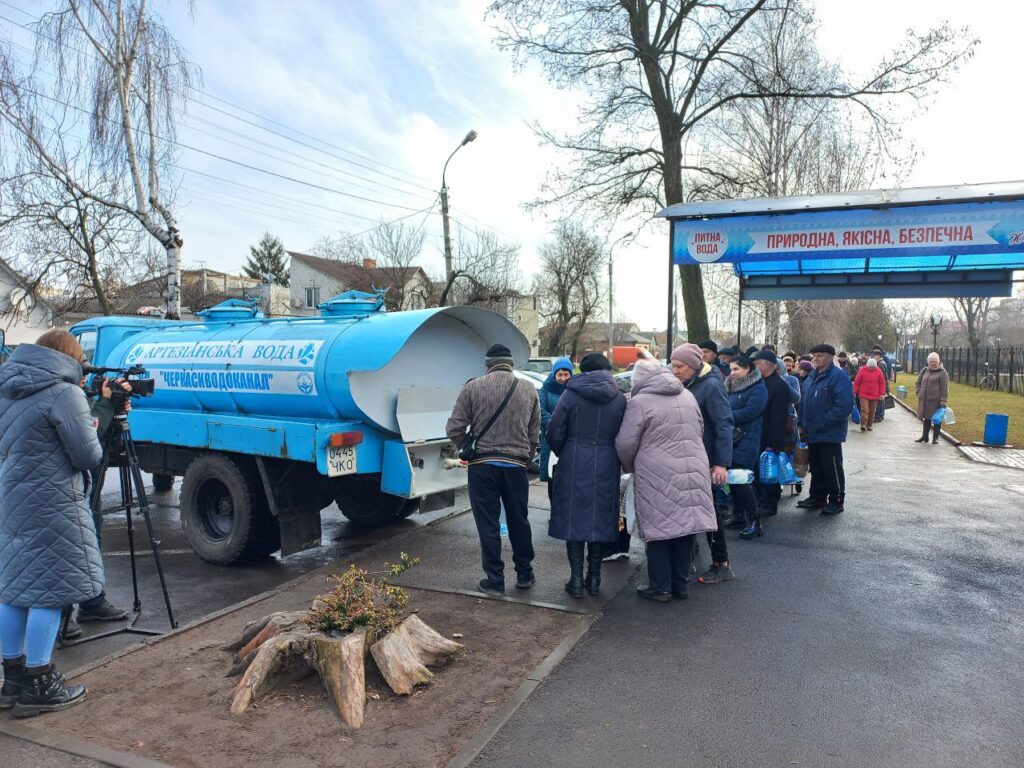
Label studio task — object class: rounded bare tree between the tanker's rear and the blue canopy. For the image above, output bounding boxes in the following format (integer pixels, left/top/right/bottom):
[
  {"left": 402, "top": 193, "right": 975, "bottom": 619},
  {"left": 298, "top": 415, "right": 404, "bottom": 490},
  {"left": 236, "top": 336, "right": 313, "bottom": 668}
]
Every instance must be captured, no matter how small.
[{"left": 534, "top": 222, "right": 608, "bottom": 356}]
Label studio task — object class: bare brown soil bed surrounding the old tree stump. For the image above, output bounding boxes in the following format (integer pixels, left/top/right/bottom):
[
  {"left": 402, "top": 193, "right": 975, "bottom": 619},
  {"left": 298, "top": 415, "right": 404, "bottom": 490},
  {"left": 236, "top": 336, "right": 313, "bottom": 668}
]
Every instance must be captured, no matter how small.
[{"left": 39, "top": 577, "right": 582, "bottom": 768}]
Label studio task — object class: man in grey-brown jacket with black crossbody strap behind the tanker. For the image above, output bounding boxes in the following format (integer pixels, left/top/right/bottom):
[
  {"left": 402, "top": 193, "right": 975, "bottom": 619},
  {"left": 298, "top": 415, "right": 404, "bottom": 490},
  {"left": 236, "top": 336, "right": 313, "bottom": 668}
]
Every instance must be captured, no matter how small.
[{"left": 446, "top": 344, "right": 541, "bottom": 595}]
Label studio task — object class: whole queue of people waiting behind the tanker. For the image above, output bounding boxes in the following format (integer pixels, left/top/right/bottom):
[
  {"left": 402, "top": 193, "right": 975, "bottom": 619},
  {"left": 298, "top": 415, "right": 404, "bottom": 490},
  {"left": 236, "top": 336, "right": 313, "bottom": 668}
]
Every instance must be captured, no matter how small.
[{"left": 447, "top": 341, "right": 897, "bottom": 602}]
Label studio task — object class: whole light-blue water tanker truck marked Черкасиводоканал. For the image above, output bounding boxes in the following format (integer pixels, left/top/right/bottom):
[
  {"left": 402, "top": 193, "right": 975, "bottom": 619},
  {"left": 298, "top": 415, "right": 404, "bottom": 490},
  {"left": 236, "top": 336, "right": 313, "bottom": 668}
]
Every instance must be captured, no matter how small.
[{"left": 70, "top": 291, "right": 529, "bottom": 564}]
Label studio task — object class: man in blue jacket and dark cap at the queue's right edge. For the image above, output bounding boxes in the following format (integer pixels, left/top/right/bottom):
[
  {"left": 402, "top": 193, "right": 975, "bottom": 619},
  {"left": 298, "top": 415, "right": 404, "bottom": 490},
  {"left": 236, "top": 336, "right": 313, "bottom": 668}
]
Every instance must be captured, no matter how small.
[{"left": 797, "top": 344, "right": 853, "bottom": 515}]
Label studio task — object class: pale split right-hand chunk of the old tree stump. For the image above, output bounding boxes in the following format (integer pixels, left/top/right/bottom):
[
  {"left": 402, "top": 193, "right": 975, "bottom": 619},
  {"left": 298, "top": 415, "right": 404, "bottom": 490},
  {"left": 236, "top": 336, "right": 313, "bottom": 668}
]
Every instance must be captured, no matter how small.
[{"left": 370, "top": 613, "right": 465, "bottom": 695}]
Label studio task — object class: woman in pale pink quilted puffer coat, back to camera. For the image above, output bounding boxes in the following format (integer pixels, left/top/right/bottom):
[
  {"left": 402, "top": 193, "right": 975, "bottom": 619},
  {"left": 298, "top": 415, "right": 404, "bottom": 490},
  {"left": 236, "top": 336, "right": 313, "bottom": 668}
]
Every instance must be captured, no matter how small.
[{"left": 615, "top": 360, "right": 717, "bottom": 602}]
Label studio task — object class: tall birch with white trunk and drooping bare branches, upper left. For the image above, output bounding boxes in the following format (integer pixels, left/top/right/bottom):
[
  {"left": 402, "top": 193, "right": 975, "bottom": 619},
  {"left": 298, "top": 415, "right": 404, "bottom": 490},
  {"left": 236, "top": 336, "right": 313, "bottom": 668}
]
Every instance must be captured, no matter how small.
[{"left": 0, "top": 0, "right": 198, "bottom": 317}]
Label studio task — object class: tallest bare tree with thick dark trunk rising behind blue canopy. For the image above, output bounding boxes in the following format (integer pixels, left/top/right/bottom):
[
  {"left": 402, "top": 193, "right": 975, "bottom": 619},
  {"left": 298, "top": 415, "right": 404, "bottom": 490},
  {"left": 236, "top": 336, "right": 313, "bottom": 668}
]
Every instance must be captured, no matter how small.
[{"left": 490, "top": 0, "right": 974, "bottom": 337}]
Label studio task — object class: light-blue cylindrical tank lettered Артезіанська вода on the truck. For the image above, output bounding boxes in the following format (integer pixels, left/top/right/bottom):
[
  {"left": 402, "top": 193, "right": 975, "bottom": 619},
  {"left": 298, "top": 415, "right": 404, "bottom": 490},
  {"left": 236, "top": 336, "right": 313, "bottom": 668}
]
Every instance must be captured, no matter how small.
[{"left": 102, "top": 292, "right": 529, "bottom": 437}]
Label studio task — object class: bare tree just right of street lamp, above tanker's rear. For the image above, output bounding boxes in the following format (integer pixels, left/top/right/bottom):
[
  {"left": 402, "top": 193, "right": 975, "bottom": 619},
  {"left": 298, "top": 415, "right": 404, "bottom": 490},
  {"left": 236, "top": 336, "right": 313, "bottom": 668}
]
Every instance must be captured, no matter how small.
[{"left": 437, "top": 229, "right": 522, "bottom": 306}]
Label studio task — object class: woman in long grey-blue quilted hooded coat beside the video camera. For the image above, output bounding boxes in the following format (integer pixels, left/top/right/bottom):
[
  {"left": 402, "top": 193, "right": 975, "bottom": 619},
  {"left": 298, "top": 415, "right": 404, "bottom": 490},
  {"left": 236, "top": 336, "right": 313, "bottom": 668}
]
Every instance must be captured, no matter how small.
[{"left": 0, "top": 329, "right": 103, "bottom": 717}]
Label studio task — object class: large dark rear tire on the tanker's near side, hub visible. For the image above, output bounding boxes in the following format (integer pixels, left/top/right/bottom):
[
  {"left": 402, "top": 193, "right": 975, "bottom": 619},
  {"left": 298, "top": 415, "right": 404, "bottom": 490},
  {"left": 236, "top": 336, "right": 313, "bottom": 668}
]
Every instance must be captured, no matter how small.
[{"left": 180, "top": 454, "right": 281, "bottom": 565}]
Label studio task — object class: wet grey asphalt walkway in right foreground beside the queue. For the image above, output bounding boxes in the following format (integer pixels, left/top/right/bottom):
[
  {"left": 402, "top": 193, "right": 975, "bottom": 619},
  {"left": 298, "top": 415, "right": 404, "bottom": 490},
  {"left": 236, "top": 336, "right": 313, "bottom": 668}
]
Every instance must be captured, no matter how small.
[{"left": 474, "top": 411, "right": 1024, "bottom": 768}]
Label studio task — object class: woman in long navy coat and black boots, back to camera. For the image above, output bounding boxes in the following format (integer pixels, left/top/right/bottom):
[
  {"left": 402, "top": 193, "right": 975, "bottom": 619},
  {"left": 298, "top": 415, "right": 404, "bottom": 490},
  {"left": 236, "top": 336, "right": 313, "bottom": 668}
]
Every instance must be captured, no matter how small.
[{"left": 548, "top": 352, "right": 626, "bottom": 598}]
